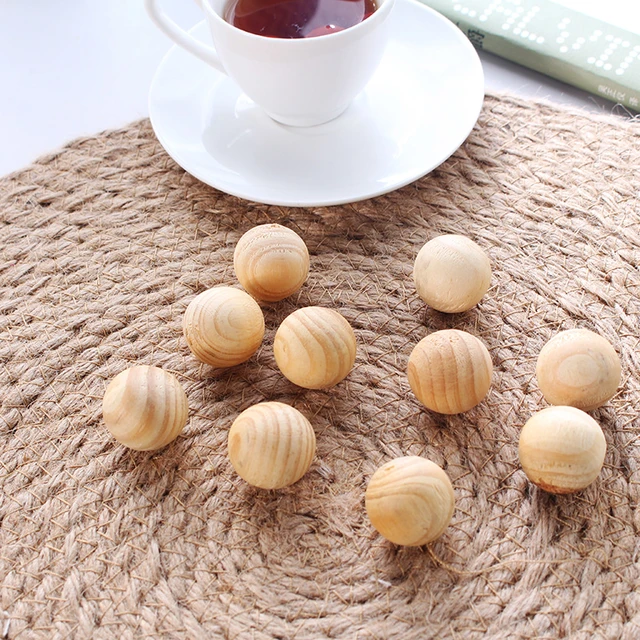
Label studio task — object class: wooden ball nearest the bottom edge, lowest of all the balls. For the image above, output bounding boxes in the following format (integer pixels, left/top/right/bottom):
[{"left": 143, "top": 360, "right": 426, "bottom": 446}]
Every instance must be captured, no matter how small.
[{"left": 365, "top": 456, "right": 455, "bottom": 547}]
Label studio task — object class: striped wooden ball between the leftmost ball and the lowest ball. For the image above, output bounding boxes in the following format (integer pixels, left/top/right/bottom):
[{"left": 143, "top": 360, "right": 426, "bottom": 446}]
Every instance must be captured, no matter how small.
[{"left": 229, "top": 402, "right": 316, "bottom": 489}]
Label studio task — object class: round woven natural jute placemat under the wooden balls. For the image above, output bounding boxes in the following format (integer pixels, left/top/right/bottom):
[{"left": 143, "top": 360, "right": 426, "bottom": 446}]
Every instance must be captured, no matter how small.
[{"left": 0, "top": 98, "right": 640, "bottom": 640}]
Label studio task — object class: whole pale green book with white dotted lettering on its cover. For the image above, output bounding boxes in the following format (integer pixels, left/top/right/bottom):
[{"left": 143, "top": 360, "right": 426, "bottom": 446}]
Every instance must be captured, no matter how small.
[{"left": 421, "top": 0, "right": 640, "bottom": 112}]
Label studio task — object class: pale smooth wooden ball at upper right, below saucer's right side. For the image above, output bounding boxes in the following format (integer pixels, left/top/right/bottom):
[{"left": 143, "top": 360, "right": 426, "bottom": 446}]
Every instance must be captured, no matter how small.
[{"left": 413, "top": 234, "right": 491, "bottom": 313}]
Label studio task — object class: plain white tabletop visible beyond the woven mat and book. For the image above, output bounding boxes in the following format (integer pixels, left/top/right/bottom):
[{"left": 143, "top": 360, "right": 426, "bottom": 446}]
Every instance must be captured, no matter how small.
[{"left": 0, "top": 0, "right": 640, "bottom": 175}]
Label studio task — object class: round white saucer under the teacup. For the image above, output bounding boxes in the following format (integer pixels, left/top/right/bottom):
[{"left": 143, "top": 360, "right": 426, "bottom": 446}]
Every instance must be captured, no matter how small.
[{"left": 149, "top": 0, "right": 484, "bottom": 207}]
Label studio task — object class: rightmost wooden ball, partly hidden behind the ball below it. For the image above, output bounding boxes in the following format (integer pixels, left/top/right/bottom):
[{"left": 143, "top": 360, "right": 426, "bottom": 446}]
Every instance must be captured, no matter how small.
[{"left": 536, "top": 329, "right": 620, "bottom": 411}]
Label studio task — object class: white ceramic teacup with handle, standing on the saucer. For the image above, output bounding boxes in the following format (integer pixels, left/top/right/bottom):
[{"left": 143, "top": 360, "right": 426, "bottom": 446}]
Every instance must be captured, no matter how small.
[{"left": 145, "top": 0, "right": 395, "bottom": 127}]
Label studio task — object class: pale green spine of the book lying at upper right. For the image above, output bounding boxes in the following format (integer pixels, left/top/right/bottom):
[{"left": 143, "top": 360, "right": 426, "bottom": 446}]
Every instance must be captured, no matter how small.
[{"left": 422, "top": 0, "right": 640, "bottom": 111}]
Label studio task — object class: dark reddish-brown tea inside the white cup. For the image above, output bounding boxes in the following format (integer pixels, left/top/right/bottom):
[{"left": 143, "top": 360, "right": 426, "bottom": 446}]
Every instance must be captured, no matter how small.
[{"left": 224, "top": 0, "right": 377, "bottom": 38}]
